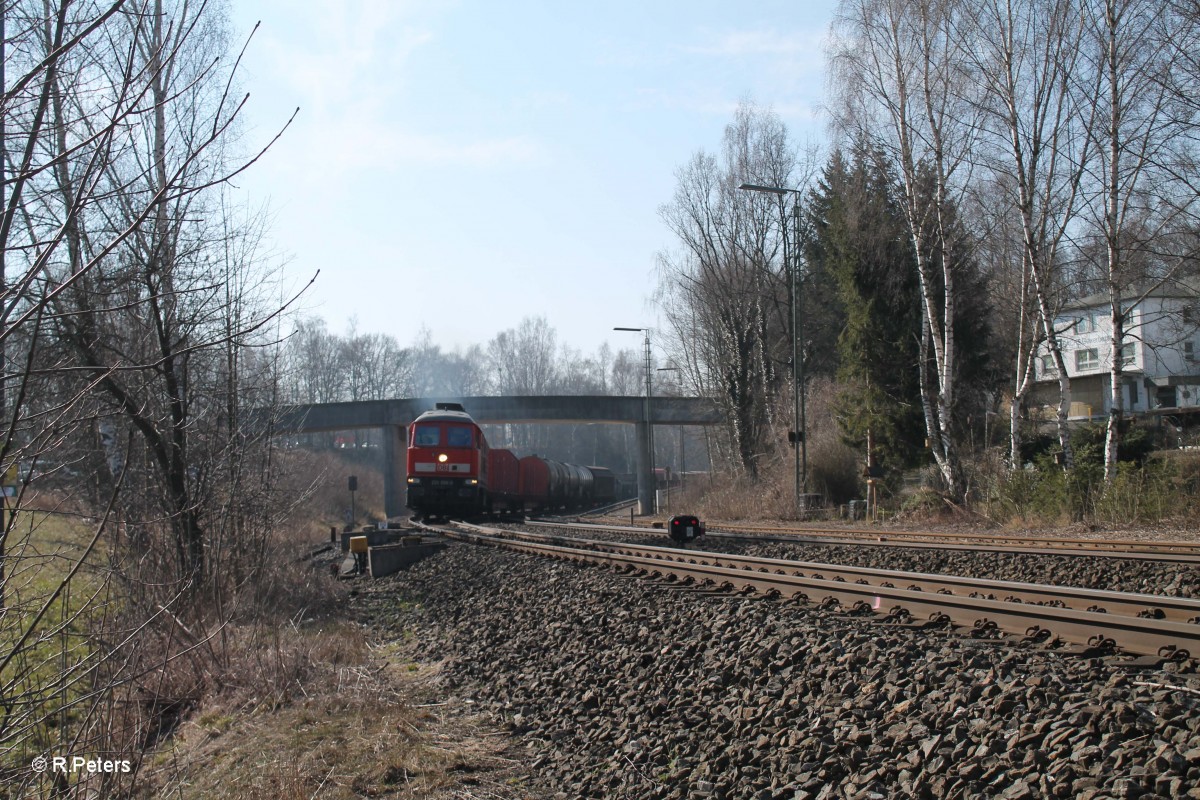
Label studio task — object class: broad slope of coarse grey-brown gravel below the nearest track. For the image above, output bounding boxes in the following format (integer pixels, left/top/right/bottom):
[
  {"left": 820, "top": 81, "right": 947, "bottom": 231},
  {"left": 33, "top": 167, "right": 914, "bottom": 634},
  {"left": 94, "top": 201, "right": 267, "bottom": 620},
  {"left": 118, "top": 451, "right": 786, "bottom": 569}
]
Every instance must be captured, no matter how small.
[{"left": 358, "top": 545, "right": 1200, "bottom": 800}]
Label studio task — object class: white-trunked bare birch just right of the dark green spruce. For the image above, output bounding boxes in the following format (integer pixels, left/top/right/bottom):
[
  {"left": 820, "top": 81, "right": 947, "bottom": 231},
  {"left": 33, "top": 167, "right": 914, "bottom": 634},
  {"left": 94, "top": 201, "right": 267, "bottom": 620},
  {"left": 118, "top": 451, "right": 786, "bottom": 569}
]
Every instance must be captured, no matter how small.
[{"left": 832, "top": 0, "right": 979, "bottom": 498}]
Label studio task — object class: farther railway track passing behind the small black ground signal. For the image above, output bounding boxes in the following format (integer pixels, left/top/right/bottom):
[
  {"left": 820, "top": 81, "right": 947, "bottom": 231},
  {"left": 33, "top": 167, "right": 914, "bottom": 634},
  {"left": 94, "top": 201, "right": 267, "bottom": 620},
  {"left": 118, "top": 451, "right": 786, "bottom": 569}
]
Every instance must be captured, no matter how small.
[{"left": 537, "top": 521, "right": 1200, "bottom": 566}]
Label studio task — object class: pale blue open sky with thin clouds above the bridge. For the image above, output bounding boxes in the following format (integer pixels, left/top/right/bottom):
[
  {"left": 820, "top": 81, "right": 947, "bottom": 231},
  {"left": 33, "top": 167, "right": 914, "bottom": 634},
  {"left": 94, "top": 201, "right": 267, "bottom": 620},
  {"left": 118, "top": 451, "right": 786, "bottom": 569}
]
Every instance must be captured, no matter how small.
[{"left": 229, "top": 0, "right": 834, "bottom": 353}]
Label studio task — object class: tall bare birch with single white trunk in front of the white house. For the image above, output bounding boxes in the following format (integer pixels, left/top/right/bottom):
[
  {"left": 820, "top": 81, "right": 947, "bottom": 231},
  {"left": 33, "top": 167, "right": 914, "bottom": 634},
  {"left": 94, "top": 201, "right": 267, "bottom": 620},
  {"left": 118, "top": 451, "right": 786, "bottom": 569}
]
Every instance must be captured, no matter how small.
[{"left": 1078, "top": 0, "right": 1195, "bottom": 481}]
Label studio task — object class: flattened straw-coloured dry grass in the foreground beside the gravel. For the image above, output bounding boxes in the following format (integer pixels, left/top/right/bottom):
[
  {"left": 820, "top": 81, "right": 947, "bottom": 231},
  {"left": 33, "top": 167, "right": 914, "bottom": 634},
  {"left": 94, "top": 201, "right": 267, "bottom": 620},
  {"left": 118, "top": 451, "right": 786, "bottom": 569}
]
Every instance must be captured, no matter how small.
[{"left": 148, "top": 624, "right": 526, "bottom": 800}]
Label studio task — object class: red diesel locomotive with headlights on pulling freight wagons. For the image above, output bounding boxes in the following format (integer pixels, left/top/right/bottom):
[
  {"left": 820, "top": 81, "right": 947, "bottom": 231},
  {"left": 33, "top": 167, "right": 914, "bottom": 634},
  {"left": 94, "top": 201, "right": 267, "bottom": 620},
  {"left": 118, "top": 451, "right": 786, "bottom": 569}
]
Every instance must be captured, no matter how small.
[{"left": 408, "top": 403, "right": 617, "bottom": 518}]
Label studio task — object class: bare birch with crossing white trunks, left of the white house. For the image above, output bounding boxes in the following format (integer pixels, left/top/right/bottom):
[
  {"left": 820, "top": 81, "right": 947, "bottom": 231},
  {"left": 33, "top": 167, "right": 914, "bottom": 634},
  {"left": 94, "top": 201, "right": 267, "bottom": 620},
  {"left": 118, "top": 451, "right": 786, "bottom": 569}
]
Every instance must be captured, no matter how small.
[{"left": 964, "top": 0, "right": 1092, "bottom": 469}]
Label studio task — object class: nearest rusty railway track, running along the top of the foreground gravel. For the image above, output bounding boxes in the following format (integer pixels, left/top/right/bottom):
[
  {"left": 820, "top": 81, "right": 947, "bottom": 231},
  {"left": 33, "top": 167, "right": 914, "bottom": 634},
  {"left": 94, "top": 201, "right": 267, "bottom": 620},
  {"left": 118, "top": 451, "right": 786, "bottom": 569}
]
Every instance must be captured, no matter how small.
[{"left": 437, "top": 523, "right": 1200, "bottom": 663}]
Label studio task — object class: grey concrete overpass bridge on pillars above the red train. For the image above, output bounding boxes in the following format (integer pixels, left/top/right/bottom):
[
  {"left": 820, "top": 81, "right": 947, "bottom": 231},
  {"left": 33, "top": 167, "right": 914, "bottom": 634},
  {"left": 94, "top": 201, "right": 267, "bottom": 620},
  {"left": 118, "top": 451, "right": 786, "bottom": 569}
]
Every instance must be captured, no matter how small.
[{"left": 275, "top": 395, "right": 724, "bottom": 517}]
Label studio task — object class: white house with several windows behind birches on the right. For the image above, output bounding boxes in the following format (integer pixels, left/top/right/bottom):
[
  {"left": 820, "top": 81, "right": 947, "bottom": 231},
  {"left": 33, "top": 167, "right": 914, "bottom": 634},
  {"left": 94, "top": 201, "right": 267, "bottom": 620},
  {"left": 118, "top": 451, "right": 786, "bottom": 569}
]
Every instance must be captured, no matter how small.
[{"left": 1031, "top": 289, "right": 1200, "bottom": 420}]
